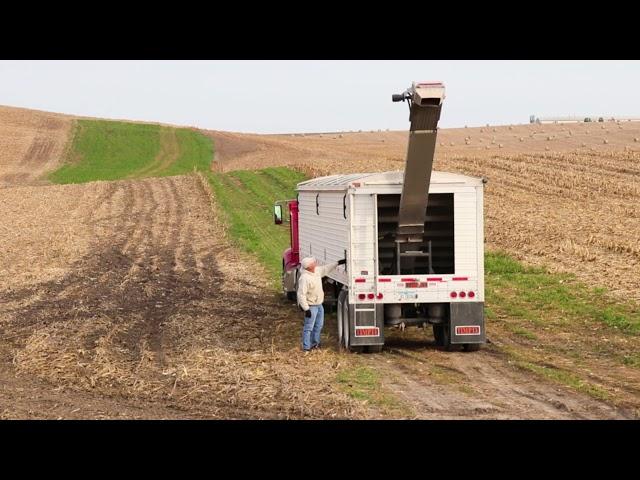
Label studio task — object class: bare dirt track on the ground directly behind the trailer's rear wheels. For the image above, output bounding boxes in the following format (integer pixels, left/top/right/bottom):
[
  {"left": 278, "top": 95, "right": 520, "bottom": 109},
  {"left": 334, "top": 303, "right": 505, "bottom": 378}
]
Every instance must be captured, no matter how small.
[{"left": 367, "top": 339, "right": 635, "bottom": 419}]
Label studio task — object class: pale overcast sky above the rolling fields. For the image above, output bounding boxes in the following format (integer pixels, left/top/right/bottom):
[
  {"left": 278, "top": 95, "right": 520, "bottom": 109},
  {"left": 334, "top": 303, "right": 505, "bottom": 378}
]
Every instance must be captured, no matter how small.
[{"left": 0, "top": 60, "right": 640, "bottom": 133}]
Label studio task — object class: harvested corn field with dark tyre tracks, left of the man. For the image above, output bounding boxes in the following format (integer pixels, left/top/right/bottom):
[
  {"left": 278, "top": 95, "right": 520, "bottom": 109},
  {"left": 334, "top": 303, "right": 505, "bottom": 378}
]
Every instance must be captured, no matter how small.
[{"left": 0, "top": 176, "right": 366, "bottom": 418}]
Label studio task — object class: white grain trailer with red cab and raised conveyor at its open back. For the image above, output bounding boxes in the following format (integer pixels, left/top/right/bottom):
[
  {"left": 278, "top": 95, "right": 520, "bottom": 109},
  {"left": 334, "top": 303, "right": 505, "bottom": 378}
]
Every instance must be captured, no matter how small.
[{"left": 276, "top": 82, "right": 486, "bottom": 352}]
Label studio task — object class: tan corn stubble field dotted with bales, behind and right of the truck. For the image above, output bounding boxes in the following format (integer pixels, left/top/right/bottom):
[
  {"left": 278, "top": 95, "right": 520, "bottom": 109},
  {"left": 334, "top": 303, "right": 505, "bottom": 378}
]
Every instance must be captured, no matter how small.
[{"left": 208, "top": 122, "right": 640, "bottom": 301}]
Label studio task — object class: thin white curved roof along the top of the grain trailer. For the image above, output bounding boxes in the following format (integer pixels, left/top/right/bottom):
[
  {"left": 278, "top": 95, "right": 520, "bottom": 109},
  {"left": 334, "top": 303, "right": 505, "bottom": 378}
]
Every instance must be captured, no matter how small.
[{"left": 298, "top": 170, "right": 483, "bottom": 190}]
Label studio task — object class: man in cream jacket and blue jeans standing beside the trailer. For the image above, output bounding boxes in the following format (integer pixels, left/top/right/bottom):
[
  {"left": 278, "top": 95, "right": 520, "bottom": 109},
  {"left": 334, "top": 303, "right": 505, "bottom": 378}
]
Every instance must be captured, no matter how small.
[{"left": 298, "top": 257, "right": 347, "bottom": 352}]
